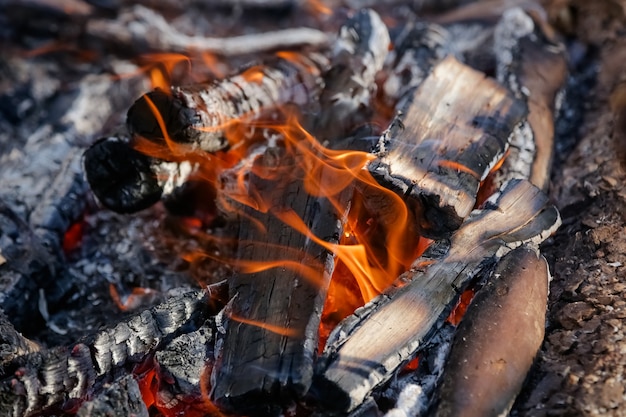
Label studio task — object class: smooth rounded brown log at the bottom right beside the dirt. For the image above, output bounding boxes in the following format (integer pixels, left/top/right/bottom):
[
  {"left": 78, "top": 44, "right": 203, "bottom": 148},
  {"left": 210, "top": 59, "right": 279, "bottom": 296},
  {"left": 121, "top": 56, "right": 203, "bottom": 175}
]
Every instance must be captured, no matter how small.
[{"left": 432, "top": 246, "right": 550, "bottom": 417}]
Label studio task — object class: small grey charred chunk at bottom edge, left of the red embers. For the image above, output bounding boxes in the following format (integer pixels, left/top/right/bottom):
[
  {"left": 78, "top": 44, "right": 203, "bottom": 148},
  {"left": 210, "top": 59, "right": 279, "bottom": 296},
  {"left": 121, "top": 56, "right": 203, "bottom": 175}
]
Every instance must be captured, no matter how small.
[{"left": 76, "top": 375, "right": 149, "bottom": 417}]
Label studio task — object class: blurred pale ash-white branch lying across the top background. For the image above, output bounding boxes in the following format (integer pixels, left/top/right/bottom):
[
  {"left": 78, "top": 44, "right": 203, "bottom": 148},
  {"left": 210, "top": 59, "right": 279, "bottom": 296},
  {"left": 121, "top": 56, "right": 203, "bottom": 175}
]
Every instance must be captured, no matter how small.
[{"left": 85, "top": 4, "right": 331, "bottom": 57}]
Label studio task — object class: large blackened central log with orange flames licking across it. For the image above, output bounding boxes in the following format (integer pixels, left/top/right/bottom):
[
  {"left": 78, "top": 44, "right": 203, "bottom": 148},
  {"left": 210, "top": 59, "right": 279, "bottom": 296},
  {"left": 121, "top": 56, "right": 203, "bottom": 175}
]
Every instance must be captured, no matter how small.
[{"left": 211, "top": 148, "right": 352, "bottom": 415}]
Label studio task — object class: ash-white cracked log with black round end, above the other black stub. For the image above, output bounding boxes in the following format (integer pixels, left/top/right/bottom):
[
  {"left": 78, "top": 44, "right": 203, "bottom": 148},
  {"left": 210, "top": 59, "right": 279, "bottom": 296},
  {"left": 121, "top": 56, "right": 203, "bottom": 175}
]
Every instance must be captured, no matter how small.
[{"left": 127, "top": 53, "right": 328, "bottom": 153}]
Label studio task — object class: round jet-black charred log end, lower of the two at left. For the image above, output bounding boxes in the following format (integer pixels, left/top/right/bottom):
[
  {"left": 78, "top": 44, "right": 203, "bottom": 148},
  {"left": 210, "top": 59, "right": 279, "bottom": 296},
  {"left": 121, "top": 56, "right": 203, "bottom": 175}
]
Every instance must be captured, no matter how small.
[{"left": 83, "top": 137, "right": 163, "bottom": 213}]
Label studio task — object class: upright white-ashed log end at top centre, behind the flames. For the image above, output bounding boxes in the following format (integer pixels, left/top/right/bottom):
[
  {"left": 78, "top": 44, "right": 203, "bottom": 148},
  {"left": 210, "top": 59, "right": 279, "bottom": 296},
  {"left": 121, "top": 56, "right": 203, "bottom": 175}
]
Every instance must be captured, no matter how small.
[{"left": 314, "top": 9, "right": 391, "bottom": 141}]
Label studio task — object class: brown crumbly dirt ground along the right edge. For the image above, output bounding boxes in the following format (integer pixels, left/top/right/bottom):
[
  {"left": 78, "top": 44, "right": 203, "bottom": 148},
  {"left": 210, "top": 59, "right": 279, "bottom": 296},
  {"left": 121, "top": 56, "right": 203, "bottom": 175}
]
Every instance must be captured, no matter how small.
[{"left": 512, "top": 0, "right": 626, "bottom": 416}]
